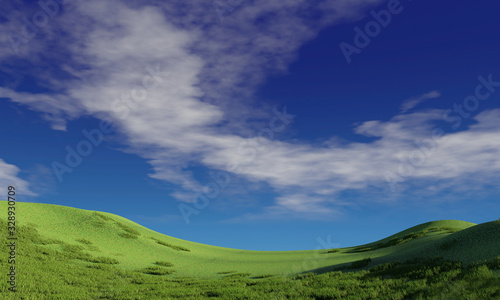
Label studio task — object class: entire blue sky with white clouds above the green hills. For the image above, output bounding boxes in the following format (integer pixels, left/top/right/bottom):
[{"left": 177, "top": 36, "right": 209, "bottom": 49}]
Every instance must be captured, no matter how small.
[{"left": 0, "top": 0, "right": 500, "bottom": 250}]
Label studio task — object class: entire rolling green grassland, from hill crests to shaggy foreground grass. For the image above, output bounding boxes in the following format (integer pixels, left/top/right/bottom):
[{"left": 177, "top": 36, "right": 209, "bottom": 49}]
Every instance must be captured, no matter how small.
[{"left": 0, "top": 201, "right": 500, "bottom": 299}]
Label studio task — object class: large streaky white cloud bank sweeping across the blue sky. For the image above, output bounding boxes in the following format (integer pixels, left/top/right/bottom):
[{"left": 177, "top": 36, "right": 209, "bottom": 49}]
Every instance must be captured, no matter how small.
[{"left": 0, "top": 0, "right": 500, "bottom": 218}]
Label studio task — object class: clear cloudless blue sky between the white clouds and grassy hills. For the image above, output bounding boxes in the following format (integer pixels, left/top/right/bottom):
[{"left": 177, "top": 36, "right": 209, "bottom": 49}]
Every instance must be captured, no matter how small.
[{"left": 0, "top": 0, "right": 500, "bottom": 250}]
